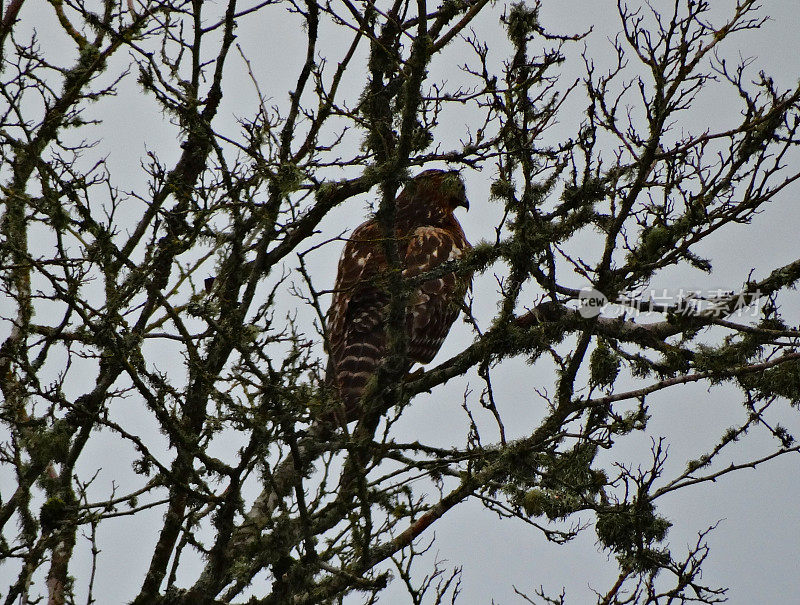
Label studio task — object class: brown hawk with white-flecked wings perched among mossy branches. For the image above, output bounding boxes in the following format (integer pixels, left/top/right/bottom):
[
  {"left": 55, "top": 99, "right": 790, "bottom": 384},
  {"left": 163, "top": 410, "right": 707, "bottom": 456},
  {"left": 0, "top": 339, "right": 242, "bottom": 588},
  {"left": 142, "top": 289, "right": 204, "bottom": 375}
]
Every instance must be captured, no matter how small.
[{"left": 326, "top": 170, "right": 472, "bottom": 422}]
